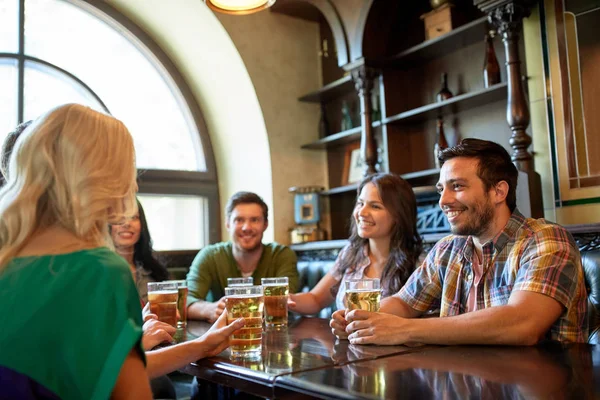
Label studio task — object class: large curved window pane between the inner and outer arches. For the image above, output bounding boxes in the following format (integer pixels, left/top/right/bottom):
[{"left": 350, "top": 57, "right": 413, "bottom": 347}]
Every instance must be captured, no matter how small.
[{"left": 25, "top": 0, "right": 206, "bottom": 171}]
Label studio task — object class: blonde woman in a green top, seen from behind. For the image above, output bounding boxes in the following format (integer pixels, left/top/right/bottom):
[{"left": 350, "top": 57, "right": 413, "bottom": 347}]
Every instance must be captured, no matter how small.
[{"left": 0, "top": 104, "right": 240, "bottom": 399}]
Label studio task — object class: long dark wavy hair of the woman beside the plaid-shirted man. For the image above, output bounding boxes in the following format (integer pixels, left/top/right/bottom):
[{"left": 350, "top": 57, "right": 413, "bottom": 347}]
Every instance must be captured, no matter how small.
[{"left": 340, "top": 173, "right": 423, "bottom": 296}]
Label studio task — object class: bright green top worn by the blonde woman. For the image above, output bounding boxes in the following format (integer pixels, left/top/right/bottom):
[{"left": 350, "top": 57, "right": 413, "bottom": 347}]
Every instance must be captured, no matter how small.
[{"left": 0, "top": 247, "right": 145, "bottom": 400}]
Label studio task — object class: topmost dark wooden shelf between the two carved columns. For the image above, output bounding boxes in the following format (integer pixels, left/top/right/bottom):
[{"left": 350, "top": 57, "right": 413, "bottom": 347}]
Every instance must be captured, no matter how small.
[{"left": 382, "top": 17, "right": 487, "bottom": 68}]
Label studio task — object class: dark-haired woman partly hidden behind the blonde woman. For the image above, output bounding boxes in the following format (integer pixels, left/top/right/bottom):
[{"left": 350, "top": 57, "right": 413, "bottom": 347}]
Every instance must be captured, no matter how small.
[{"left": 110, "top": 200, "right": 169, "bottom": 304}]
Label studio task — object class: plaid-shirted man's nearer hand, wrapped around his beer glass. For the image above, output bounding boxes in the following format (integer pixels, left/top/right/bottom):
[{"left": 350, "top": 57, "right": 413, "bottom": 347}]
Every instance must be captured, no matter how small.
[{"left": 338, "top": 310, "right": 411, "bottom": 345}]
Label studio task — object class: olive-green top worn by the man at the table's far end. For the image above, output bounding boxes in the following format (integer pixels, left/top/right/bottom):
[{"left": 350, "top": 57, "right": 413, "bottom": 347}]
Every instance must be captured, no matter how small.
[{"left": 187, "top": 242, "right": 298, "bottom": 305}]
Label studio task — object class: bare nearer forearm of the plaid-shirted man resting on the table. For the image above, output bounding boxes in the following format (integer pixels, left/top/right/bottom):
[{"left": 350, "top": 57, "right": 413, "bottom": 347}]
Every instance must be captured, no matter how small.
[{"left": 406, "top": 305, "right": 540, "bottom": 345}]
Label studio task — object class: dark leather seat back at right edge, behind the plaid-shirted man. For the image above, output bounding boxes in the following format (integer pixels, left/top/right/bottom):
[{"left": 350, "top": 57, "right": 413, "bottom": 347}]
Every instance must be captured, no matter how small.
[{"left": 581, "top": 250, "right": 600, "bottom": 344}]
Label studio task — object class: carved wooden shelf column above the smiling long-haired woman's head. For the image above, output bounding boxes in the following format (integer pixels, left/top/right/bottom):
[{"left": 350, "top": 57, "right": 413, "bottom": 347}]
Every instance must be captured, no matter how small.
[{"left": 351, "top": 64, "right": 377, "bottom": 176}]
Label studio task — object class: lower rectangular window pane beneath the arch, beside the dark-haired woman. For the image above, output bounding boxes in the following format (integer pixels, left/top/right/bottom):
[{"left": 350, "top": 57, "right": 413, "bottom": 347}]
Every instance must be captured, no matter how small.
[{"left": 138, "top": 194, "right": 208, "bottom": 250}]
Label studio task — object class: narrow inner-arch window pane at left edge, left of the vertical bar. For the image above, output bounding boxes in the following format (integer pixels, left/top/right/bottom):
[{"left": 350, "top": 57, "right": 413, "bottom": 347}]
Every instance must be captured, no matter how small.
[{"left": 0, "top": 59, "right": 18, "bottom": 144}]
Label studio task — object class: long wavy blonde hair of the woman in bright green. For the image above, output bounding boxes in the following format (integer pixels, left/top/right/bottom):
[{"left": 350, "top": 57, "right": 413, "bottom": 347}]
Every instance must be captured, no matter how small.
[{"left": 0, "top": 104, "right": 137, "bottom": 272}]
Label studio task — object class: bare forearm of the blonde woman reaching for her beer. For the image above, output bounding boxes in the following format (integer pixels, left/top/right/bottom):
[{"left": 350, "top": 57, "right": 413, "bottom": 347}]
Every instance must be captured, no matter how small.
[{"left": 146, "top": 340, "right": 205, "bottom": 379}]
